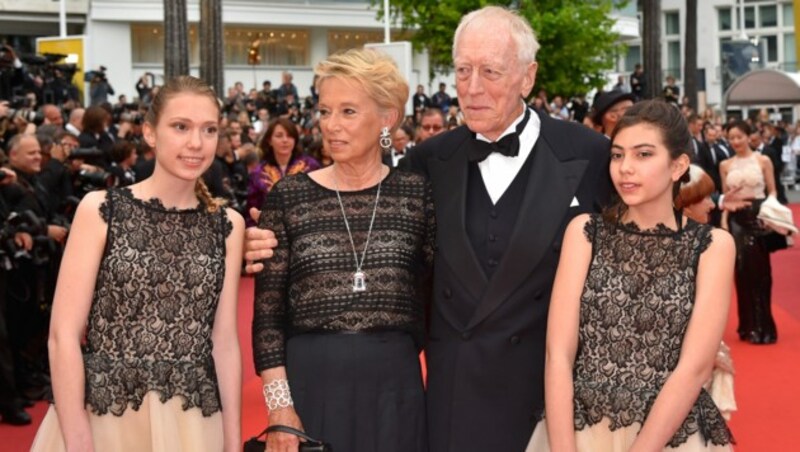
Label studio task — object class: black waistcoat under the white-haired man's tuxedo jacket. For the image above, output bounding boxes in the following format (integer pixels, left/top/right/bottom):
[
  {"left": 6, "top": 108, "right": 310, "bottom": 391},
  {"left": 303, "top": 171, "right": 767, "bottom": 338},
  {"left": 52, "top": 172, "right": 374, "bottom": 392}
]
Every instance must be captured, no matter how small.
[{"left": 466, "top": 149, "right": 535, "bottom": 279}]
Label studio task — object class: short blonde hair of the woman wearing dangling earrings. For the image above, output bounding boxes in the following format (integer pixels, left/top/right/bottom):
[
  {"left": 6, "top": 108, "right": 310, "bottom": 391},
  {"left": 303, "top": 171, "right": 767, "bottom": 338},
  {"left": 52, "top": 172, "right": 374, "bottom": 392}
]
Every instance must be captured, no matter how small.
[{"left": 314, "top": 48, "right": 408, "bottom": 130}]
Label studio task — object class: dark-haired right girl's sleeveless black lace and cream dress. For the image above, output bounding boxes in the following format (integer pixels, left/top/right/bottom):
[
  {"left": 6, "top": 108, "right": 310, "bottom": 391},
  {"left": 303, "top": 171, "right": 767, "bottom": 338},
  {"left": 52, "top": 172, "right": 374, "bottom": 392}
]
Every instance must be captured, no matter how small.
[{"left": 527, "top": 215, "right": 733, "bottom": 452}]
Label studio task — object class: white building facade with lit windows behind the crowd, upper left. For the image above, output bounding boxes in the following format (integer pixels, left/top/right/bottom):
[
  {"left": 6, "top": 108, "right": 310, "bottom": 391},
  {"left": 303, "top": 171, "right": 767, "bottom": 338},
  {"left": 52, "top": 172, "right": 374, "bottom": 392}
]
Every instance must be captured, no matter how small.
[{"left": 0, "top": 0, "right": 640, "bottom": 107}]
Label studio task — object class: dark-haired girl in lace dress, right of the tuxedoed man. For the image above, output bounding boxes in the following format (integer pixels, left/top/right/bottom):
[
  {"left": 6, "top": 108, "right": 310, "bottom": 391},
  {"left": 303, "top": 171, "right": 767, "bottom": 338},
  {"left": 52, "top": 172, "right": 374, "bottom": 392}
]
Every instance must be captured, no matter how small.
[{"left": 528, "top": 101, "right": 735, "bottom": 452}]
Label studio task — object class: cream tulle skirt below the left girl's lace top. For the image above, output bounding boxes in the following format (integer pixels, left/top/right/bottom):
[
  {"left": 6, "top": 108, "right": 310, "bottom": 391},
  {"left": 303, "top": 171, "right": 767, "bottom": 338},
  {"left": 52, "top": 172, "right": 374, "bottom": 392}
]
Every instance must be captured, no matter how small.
[{"left": 31, "top": 392, "right": 223, "bottom": 452}]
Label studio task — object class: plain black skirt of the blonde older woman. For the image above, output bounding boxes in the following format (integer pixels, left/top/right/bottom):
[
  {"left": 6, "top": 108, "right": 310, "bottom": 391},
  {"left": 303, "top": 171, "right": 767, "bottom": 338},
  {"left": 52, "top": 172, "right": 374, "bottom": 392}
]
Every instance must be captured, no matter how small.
[{"left": 286, "top": 332, "right": 428, "bottom": 452}]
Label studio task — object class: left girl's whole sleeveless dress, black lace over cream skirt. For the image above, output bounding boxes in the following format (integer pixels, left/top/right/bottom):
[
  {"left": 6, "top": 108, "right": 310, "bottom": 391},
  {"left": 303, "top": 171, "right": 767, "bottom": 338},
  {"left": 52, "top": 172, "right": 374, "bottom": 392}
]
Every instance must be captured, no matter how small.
[{"left": 31, "top": 188, "right": 232, "bottom": 452}]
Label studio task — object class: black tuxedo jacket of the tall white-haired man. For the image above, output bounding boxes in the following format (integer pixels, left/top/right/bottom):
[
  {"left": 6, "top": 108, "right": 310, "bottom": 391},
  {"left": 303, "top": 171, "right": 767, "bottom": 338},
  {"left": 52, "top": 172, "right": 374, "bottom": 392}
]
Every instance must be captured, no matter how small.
[{"left": 404, "top": 110, "right": 611, "bottom": 452}]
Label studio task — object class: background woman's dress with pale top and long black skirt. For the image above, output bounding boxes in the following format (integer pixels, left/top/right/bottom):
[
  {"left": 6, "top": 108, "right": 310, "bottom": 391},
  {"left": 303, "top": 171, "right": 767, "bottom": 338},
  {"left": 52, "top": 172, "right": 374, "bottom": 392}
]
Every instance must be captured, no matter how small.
[{"left": 725, "top": 152, "right": 778, "bottom": 344}]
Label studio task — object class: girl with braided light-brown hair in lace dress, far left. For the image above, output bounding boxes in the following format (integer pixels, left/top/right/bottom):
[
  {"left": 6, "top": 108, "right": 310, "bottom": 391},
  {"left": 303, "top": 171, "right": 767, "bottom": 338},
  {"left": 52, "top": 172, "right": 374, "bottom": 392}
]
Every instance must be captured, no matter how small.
[{"left": 32, "top": 77, "right": 244, "bottom": 452}]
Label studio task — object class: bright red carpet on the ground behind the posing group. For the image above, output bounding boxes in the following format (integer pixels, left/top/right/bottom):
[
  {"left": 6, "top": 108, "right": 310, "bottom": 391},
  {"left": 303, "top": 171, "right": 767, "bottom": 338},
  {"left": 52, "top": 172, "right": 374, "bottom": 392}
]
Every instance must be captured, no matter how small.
[{"left": 0, "top": 204, "right": 800, "bottom": 452}]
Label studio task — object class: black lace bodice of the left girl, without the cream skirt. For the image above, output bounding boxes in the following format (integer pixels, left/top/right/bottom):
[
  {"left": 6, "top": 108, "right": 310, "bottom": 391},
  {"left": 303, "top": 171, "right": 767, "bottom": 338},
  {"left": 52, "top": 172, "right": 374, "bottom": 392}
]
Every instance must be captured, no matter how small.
[{"left": 84, "top": 188, "right": 232, "bottom": 416}]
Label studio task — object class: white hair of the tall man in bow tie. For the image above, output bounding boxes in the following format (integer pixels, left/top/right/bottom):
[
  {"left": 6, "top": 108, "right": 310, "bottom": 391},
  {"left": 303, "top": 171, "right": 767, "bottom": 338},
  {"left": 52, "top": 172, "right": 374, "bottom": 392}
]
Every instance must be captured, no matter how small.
[{"left": 453, "top": 6, "right": 539, "bottom": 66}]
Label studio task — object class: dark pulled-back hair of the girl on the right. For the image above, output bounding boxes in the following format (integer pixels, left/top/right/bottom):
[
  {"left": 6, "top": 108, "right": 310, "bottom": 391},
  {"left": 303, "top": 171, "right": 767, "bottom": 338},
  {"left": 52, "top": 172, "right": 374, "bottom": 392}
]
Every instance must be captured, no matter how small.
[{"left": 603, "top": 100, "right": 694, "bottom": 223}]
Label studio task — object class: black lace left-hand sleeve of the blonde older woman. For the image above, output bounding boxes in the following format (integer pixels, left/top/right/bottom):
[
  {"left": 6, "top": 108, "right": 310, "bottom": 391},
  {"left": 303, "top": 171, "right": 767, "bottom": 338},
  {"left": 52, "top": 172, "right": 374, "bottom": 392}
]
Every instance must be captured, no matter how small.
[{"left": 253, "top": 187, "right": 290, "bottom": 373}]
